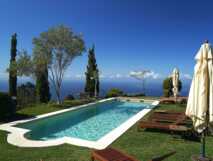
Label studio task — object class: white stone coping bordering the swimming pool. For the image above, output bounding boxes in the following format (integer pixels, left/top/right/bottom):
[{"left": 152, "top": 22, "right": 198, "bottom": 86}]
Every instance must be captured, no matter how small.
[{"left": 0, "top": 98, "right": 159, "bottom": 150}]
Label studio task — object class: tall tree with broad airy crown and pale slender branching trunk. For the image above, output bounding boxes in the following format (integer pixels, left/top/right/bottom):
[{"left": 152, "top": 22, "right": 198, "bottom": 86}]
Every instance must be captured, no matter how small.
[{"left": 33, "top": 25, "right": 85, "bottom": 104}]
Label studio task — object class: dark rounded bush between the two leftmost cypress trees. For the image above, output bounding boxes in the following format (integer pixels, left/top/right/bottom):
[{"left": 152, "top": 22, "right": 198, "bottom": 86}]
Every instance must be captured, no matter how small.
[{"left": 17, "top": 82, "right": 37, "bottom": 108}]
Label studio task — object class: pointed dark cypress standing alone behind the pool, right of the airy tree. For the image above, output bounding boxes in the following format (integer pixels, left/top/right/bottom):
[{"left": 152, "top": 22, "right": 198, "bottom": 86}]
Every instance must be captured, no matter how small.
[{"left": 85, "top": 46, "right": 99, "bottom": 97}]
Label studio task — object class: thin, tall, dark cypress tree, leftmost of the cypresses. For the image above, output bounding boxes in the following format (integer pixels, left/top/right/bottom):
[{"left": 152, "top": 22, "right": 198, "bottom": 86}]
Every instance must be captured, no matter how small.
[{"left": 9, "top": 33, "right": 17, "bottom": 97}]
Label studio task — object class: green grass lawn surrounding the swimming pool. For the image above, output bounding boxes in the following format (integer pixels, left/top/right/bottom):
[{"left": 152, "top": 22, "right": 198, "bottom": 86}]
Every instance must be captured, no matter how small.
[{"left": 0, "top": 102, "right": 213, "bottom": 161}]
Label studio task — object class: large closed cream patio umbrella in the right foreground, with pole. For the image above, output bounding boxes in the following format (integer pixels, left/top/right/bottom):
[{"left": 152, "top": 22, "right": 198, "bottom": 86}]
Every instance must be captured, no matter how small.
[{"left": 186, "top": 41, "right": 213, "bottom": 161}]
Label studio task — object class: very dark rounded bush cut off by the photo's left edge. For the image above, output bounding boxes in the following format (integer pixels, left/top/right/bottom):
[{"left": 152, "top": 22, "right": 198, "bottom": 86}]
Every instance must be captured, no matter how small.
[{"left": 0, "top": 92, "right": 16, "bottom": 120}]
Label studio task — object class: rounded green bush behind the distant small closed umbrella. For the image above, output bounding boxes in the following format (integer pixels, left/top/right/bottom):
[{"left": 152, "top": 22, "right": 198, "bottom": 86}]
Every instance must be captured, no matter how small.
[{"left": 163, "top": 77, "right": 182, "bottom": 97}]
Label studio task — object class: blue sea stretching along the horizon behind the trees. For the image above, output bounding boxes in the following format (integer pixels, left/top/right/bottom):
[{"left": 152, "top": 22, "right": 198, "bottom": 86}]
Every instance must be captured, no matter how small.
[{"left": 0, "top": 80, "right": 191, "bottom": 100}]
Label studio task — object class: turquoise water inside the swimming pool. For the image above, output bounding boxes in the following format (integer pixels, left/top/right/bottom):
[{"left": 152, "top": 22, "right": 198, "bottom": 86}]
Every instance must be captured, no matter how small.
[{"left": 18, "top": 100, "right": 151, "bottom": 141}]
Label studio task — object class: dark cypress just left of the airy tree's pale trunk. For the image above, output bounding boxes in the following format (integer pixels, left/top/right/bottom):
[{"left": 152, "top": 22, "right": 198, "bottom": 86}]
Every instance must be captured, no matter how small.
[{"left": 36, "top": 67, "right": 51, "bottom": 103}]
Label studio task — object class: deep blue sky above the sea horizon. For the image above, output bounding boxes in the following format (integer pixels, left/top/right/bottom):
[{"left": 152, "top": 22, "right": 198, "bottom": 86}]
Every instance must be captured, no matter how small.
[{"left": 0, "top": 0, "right": 213, "bottom": 80}]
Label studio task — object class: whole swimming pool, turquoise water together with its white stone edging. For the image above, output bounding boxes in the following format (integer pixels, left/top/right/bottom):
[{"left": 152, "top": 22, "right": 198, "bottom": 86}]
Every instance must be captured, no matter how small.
[{"left": 0, "top": 99, "right": 158, "bottom": 149}]
